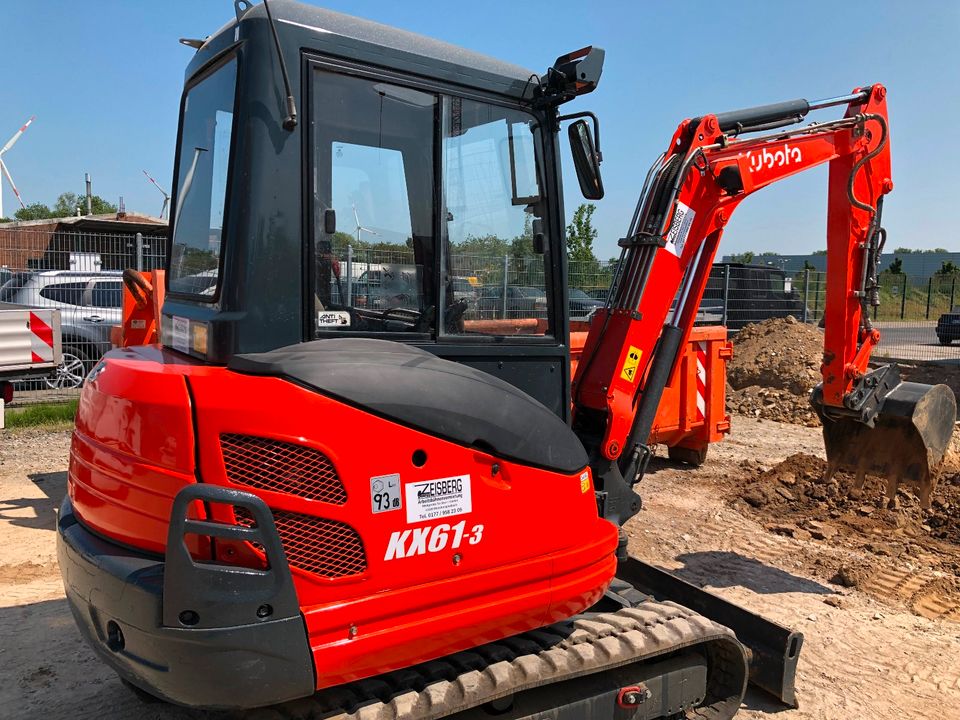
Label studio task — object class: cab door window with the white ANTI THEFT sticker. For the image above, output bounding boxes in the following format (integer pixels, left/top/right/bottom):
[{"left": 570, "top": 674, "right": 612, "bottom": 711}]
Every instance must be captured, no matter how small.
[{"left": 312, "top": 70, "right": 438, "bottom": 335}]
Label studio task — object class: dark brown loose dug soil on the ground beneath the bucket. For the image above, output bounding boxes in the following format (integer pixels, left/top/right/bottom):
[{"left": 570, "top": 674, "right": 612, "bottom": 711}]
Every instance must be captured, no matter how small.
[{"left": 728, "top": 439, "right": 960, "bottom": 622}]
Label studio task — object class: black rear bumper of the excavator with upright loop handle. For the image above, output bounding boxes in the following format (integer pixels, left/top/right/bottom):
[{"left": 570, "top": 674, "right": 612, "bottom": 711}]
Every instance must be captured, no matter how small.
[{"left": 57, "top": 486, "right": 316, "bottom": 708}]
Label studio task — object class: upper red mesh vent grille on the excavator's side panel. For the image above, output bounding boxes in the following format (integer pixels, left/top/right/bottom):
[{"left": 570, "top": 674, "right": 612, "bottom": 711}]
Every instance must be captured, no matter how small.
[{"left": 220, "top": 433, "right": 347, "bottom": 505}]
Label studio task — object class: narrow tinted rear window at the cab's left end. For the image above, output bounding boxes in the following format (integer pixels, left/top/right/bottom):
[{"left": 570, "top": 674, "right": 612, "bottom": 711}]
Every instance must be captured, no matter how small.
[{"left": 169, "top": 58, "right": 237, "bottom": 299}]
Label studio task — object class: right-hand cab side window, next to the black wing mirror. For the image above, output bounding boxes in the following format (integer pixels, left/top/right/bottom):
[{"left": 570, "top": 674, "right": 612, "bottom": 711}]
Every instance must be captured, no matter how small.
[{"left": 441, "top": 97, "right": 551, "bottom": 337}]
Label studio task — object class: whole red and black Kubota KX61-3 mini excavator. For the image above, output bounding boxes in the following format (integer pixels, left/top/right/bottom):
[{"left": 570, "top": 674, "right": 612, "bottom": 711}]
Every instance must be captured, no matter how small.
[{"left": 58, "top": 0, "right": 956, "bottom": 720}]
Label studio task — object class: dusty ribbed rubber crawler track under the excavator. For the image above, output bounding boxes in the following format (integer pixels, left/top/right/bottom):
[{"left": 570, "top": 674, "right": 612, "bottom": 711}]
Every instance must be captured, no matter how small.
[{"left": 260, "top": 601, "right": 747, "bottom": 720}]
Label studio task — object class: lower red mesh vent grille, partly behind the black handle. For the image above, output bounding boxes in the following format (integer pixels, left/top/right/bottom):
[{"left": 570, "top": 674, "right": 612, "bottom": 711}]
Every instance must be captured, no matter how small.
[{"left": 233, "top": 507, "right": 367, "bottom": 578}]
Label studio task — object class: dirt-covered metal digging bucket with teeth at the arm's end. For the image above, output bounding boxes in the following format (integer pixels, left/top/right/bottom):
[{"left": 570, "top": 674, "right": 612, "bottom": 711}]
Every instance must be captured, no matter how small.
[{"left": 810, "top": 382, "right": 957, "bottom": 508}]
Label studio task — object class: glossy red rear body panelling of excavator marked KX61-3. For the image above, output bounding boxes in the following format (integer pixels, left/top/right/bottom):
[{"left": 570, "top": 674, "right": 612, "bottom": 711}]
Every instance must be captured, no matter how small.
[{"left": 70, "top": 347, "right": 618, "bottom": 687}]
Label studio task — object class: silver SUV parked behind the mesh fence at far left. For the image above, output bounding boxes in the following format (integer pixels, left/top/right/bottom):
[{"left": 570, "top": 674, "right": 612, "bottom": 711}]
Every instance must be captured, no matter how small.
[{"left": 0, "top": 270, "right": 123, "bottom": 388}]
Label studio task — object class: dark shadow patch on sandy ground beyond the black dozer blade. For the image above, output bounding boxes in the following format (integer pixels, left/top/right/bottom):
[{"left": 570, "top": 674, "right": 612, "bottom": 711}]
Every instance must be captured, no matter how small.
[{"left": 670, "top": 550, "right": 834, "bottom": 595}]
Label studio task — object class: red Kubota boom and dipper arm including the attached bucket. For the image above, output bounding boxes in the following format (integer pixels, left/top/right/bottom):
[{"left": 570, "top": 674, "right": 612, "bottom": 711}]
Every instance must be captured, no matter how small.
[{"left": 573, "top": 85, "right": 956, "bottom": 523}]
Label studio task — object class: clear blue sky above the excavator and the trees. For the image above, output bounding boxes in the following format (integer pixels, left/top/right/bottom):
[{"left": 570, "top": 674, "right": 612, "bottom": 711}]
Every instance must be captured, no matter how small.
[{"left": 0, "top": 0, "right": 960, "bottom": 258}]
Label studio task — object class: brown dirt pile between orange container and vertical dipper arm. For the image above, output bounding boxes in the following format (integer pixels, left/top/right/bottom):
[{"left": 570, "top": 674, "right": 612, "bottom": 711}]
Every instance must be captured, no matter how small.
[{"left": 727, "top": 317, "right": 823, "bottom": 427}]
